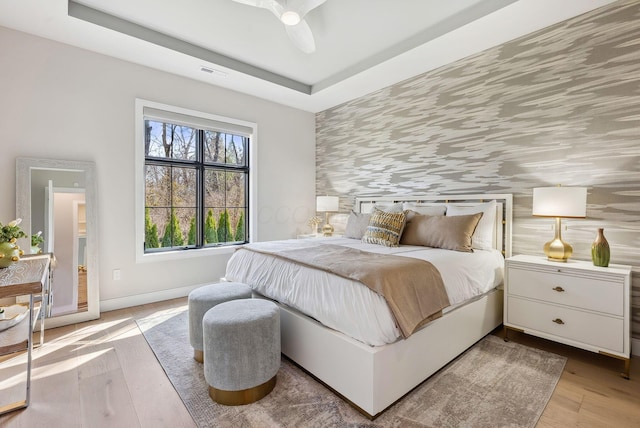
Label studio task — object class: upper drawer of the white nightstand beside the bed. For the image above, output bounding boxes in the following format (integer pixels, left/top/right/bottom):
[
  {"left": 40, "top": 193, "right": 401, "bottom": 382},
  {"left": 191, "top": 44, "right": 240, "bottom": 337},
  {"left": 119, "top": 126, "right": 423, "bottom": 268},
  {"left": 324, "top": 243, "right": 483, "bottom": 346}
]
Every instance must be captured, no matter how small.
[{"left": 507, "top": 267, "right": 624, "bottom": 317}]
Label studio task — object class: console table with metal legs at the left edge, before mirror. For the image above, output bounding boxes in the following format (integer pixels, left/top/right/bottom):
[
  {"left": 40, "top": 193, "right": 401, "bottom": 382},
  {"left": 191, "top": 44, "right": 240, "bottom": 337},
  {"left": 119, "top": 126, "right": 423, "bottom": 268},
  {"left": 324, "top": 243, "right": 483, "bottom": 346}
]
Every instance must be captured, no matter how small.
[{"left": 0, "top": 255, "right": 50, "bottom": 415}]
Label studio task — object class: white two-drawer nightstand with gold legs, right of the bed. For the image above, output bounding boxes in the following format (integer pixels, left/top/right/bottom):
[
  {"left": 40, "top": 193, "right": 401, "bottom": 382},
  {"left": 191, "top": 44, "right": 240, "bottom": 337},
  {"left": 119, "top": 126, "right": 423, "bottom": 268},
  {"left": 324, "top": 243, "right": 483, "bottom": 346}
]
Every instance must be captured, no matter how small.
[{"left": 504, "top": 255, "right": 631, "bottom": 379}]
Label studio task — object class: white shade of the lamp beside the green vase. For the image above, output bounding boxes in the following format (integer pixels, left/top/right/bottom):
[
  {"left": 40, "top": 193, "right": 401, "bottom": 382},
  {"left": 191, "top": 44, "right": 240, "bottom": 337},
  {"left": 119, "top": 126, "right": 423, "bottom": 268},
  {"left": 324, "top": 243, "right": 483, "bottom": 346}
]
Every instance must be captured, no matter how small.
[{"left": 533, "top": 186, "right": 587, "bottom": 218}]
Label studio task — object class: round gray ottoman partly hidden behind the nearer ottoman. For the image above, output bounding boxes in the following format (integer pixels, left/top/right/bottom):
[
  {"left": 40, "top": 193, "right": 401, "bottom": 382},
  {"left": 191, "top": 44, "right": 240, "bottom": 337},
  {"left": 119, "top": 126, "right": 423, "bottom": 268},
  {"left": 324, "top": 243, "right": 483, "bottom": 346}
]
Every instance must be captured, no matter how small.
[{"left": 189, "top": 282, "right": 251, "bottom": 363}]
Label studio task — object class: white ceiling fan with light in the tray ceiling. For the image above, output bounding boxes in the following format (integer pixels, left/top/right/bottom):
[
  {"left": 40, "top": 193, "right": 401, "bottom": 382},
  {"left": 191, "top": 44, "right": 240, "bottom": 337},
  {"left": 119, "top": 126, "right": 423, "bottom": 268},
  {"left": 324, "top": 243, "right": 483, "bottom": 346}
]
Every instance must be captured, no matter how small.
[{"left": 233, "top": 0, "right": 326, "bottom": 53}]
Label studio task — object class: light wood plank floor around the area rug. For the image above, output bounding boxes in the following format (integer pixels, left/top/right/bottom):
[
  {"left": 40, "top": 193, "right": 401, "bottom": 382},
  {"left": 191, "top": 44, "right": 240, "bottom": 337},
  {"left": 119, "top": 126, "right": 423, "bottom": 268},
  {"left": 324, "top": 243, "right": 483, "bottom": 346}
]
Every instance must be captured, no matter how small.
[{"left": 0, "top": 298, "right": 640, "bottom": 428}]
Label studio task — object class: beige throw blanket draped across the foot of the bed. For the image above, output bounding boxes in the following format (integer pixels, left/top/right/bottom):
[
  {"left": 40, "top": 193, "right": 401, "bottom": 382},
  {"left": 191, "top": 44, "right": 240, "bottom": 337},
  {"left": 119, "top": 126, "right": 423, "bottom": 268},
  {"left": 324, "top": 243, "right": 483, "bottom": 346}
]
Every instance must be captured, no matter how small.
[{"left": 241, "top": 242, "right": 449, "bottom": 338}]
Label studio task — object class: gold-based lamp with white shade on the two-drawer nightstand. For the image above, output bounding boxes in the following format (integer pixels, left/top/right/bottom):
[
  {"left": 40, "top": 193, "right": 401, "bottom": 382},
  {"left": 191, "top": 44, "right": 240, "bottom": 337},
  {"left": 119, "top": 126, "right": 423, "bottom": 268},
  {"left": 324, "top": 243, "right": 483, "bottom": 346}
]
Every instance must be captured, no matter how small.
[{"left": 533, "top": 186, "right": 587, "bottom": 262}]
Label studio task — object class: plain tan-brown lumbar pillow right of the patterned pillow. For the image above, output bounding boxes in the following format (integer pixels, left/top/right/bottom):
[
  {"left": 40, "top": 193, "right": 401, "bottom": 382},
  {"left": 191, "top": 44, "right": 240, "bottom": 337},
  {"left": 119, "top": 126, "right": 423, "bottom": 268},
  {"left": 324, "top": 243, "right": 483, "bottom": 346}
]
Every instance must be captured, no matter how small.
[{"left": 400, "top": 213, "right": 482, "bottom": 253}]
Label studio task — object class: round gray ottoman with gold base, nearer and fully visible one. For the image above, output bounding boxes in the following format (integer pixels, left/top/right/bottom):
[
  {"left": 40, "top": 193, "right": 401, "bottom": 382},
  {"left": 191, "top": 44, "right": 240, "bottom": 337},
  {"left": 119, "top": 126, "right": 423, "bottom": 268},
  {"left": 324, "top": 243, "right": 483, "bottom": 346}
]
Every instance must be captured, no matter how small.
[{"left": 202, "top": 299, "right": 280, "bottom": 406}]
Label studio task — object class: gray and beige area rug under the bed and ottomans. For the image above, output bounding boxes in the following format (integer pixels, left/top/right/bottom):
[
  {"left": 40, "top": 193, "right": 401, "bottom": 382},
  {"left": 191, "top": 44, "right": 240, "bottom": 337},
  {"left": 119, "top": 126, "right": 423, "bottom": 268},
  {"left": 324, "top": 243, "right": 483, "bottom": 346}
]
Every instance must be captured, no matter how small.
[{"left": 137, "top": 307, "right": 566, "bottom": 428}]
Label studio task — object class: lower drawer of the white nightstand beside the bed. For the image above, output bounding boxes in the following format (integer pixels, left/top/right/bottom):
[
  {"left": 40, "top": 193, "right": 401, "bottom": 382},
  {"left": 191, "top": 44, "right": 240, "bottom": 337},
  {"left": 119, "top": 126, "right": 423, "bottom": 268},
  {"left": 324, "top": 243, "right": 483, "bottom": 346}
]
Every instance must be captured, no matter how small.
[{"left": 506, "top": 297, "right": 624, "bottom": 352}]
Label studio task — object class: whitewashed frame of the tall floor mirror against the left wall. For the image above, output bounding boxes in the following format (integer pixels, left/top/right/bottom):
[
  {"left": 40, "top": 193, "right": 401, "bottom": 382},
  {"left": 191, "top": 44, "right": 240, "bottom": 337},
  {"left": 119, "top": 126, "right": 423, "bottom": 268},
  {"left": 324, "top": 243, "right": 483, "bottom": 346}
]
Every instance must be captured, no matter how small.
[{"left": 16, "top": 157, "right": 100, "bottom": 328}]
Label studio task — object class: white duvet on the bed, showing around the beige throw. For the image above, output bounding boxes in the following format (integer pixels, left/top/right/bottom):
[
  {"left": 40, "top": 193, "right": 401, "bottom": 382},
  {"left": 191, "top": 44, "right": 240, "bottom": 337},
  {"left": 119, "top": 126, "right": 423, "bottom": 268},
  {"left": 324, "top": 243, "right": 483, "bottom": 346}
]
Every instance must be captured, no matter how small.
[{"left": 225, "top": 238, "right": 504, "bottom": 346}]
